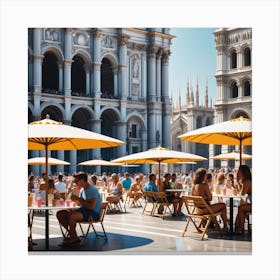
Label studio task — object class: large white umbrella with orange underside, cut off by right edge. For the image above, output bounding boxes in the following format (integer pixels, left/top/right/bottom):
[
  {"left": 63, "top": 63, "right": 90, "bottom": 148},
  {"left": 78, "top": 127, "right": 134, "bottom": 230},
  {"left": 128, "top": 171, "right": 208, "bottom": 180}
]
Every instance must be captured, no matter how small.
[{"left": 178, "top": 117, "right": 252, "bottom": 162}]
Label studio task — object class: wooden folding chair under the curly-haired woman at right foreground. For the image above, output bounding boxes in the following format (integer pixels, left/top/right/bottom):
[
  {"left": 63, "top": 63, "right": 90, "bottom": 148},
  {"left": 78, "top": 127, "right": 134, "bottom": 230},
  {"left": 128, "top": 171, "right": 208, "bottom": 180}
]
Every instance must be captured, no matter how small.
[{"left": 182, "top": 196, "right": 222, "bottom": 240}]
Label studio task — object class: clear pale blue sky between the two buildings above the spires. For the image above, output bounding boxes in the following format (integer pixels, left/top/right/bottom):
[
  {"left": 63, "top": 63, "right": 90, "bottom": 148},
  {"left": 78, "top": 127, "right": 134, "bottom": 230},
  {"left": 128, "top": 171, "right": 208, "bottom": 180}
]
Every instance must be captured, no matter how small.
[{"left": 169, "top": 28, "right": 216, "bottom": 107}]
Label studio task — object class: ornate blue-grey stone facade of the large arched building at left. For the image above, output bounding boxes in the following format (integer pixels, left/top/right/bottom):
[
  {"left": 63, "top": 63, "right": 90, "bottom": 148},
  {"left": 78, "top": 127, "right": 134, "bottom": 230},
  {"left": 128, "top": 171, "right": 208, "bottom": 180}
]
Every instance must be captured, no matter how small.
[{"left": 28, "top": 28, "right": 173, "bottom": 174}]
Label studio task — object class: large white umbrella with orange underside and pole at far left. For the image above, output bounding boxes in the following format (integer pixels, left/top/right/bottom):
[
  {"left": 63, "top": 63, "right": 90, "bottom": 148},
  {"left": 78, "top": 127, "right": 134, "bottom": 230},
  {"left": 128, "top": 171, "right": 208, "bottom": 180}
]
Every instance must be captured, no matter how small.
[{"left": 28, "top": 115, "right": 124, "bottom": 205}]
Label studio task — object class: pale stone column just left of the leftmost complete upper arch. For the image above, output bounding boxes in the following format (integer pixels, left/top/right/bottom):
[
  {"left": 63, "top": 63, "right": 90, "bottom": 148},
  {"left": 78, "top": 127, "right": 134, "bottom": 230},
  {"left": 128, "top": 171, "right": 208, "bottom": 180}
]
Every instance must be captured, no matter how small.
[{"left": 33, "top": 28, "right": 44, "bottom": 93}]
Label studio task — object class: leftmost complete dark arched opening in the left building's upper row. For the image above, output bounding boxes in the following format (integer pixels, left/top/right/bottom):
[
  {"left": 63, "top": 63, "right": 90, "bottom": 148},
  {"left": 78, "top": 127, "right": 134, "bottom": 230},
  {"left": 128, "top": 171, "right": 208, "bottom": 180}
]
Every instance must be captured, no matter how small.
[{"left": 42, "top": 52, "right": 58, "bottom": 93}]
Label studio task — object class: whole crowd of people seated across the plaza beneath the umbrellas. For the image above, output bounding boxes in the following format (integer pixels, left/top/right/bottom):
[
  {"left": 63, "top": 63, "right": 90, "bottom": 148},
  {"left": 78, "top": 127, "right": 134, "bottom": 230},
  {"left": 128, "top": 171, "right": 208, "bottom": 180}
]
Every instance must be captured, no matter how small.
[{"left": 28, "top": 165, "right": 252, "bottom": 245}]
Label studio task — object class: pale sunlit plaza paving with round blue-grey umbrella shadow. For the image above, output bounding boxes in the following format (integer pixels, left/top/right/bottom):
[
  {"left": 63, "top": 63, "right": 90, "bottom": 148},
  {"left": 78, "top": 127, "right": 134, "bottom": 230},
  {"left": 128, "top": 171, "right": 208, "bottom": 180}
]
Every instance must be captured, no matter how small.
[{"left": 29, "top": 202, "right": 252, "bottom": 255}]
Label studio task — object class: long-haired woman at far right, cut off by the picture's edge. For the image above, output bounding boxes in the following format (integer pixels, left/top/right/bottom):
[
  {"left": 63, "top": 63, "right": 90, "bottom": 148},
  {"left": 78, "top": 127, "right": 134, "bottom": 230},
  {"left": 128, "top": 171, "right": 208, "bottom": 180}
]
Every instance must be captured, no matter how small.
[{"left": 235, "top": 165, "right": 252, "bottom": 234}]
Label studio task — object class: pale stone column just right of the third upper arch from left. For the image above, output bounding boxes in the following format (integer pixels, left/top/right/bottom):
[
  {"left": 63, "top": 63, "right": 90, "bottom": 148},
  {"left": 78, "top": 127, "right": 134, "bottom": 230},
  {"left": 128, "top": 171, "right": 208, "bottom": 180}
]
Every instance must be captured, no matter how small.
[{"left": 118, "top": 35, "right": 128, "bottom": 100}]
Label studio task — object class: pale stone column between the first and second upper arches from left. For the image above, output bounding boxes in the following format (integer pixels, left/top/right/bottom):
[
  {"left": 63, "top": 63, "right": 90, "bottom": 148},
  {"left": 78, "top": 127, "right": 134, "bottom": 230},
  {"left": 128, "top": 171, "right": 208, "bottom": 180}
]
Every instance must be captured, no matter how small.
[{"left": 64, "top": 28, "right": 73, "bottom": 96}]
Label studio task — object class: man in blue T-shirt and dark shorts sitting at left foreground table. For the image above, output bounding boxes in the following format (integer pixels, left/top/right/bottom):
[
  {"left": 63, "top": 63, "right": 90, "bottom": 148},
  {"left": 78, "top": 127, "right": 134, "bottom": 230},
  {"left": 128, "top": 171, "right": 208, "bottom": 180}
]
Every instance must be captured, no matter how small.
[{"left": 56, "top": 172, "right": 102, "bottom": 245}]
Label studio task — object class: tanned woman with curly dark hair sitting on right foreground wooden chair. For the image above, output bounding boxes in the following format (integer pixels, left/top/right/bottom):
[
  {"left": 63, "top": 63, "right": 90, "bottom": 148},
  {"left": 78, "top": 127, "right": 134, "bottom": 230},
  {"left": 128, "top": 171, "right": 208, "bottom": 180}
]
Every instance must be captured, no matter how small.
[{"left": 192, "top": 167, "right": 228, "bottom": 233}]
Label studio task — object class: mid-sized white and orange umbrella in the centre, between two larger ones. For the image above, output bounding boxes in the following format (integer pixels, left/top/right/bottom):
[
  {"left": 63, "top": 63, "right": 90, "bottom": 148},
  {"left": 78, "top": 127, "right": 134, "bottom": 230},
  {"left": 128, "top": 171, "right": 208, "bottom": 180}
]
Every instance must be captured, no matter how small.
[{"left": 112, "top": 146, "right": 206, "bottom": 188}]
